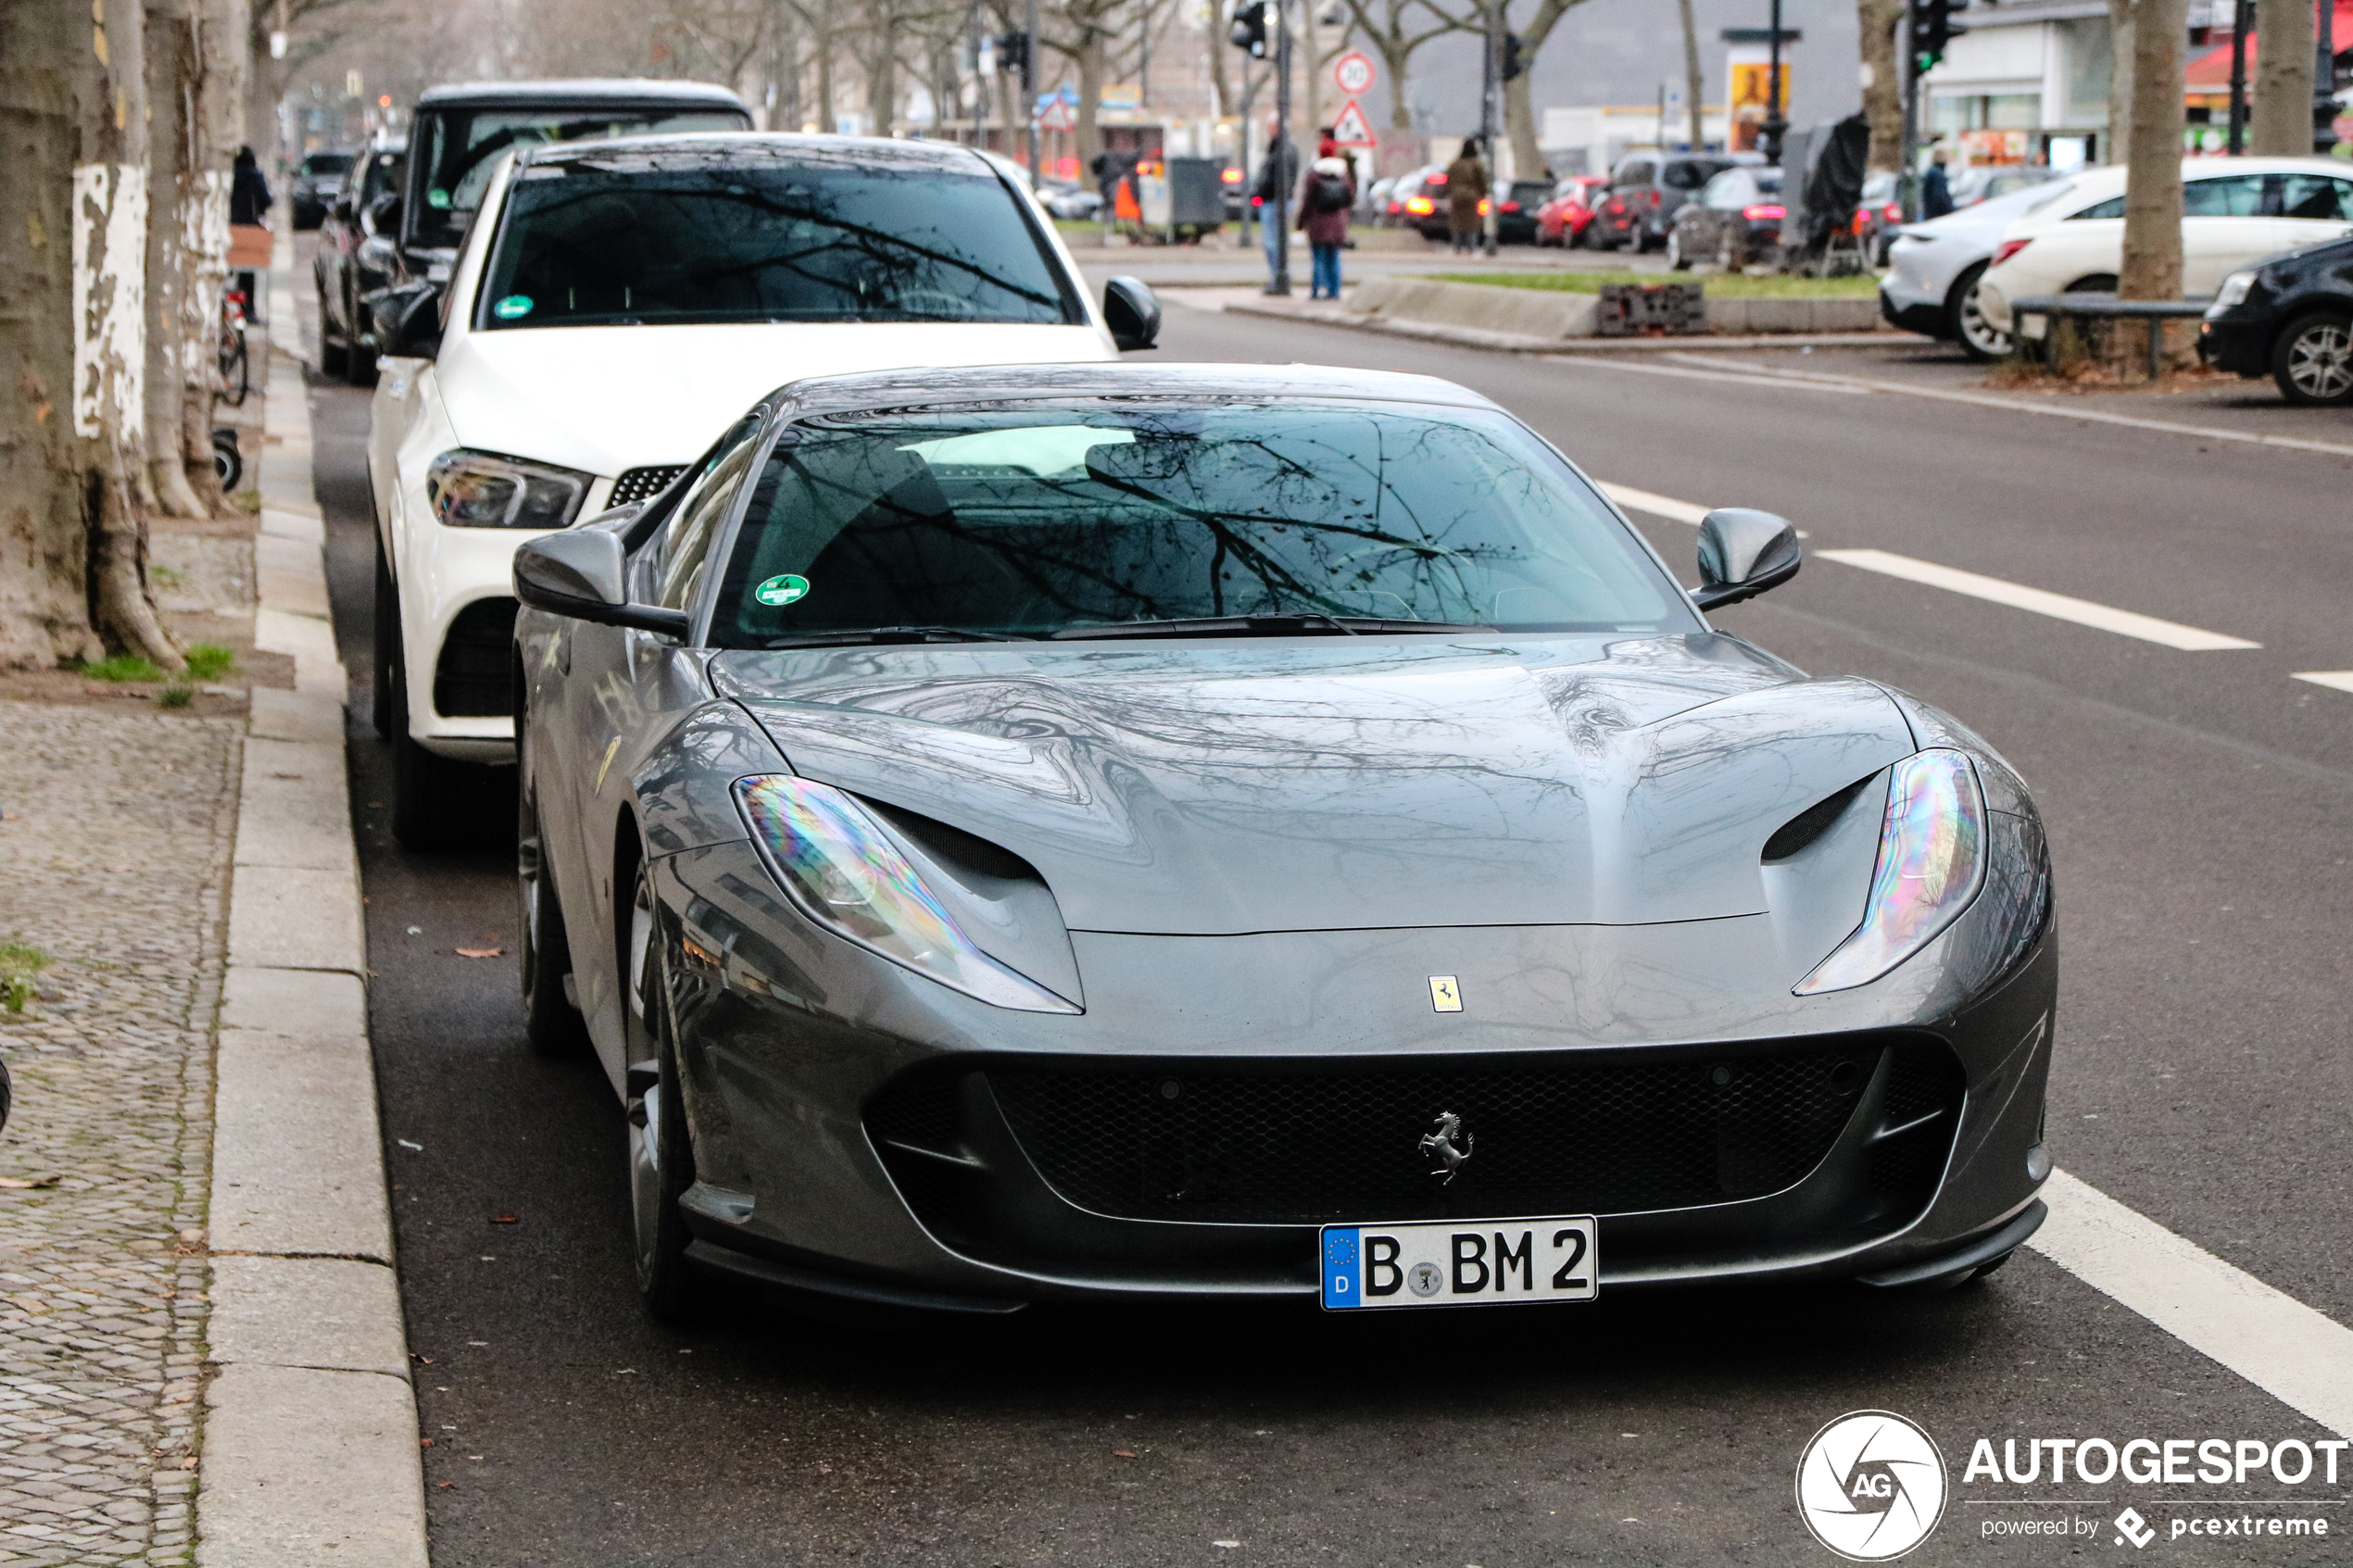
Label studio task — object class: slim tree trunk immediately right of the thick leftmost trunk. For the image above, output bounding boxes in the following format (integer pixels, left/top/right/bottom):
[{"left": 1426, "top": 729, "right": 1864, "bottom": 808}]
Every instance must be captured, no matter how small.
[{"left": 145, "top": 0, "right": 209, "bottom": 517}]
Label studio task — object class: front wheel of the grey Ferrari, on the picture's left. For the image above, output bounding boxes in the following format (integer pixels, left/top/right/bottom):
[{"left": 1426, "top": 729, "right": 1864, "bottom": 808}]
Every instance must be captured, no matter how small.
[{"left": 623, "top": 860, "right": 703, "bottom": 1323}]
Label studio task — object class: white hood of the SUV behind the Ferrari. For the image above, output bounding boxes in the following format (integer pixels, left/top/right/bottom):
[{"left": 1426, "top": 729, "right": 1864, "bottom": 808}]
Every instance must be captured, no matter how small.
[{"left": 435, "top": 322, "right": 1118, "bottom": 477}]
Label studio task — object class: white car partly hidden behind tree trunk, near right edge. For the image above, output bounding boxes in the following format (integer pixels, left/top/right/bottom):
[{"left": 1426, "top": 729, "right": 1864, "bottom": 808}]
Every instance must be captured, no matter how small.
[{"left": 1977, "top": 157, "right": 2353, "bottom": 332}]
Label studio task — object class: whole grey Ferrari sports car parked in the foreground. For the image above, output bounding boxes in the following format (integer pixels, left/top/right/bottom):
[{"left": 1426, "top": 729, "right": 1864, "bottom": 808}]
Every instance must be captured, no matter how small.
[{"left": 513, "top": 364, "right": 2059, "bottom": 1314}]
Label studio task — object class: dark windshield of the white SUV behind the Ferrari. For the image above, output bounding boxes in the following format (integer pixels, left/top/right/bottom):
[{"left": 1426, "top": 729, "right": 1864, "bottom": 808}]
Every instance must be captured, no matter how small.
[{"left": 475, "top": 145, "right": 1085, "bottom": 329}]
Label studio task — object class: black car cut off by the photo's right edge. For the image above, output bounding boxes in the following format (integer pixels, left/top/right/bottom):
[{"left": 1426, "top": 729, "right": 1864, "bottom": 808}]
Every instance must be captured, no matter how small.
[{"left": 2197, "top": 240, "right": 2353, "bottom": 407}]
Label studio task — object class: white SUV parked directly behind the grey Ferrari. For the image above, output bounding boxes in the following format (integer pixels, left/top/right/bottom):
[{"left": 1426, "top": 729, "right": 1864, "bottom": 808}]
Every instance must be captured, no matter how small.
[{"left": 367, "top": 132, "right": 1160, "bottom": 847}]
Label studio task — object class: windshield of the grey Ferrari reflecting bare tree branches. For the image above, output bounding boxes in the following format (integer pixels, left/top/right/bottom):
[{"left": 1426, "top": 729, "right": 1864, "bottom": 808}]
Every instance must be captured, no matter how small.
[{"left": 711, "top": 399, "right": 1699, "bottom": 649}]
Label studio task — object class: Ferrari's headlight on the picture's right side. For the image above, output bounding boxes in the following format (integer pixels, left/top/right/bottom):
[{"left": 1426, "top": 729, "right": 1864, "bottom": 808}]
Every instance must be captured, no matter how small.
[{"left": 1795, "top": 747, "right": 1986, "bottom": 997}]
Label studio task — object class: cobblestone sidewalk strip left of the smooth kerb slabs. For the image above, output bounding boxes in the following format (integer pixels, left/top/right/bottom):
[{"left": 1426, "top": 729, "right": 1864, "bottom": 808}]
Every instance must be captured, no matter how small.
[{"left": 0, "top": 703, "right": 245, "bottom": 1563}]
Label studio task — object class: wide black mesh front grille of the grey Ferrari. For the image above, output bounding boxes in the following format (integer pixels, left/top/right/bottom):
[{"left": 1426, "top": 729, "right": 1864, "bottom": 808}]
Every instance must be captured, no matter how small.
[{"left": 941, "top": 1041, "right": 1957, "bottom": 1224}]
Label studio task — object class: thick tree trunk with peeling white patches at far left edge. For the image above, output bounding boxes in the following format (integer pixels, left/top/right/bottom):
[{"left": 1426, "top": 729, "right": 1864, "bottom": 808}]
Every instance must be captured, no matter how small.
[{"left": 0, "top": 0, "right": 179, "bottom": 668}]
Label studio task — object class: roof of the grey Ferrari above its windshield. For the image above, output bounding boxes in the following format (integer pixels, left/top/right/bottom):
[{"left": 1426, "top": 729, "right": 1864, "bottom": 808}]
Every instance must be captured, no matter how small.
[{"left": 770, "top": 364, "right": 1496, "bottom": 420}]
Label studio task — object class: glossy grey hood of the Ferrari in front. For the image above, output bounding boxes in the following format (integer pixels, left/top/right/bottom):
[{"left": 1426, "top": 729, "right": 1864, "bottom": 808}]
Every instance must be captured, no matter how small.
[{"left": 713, "top": 634, "right": 1913, "bottom": 935}]
